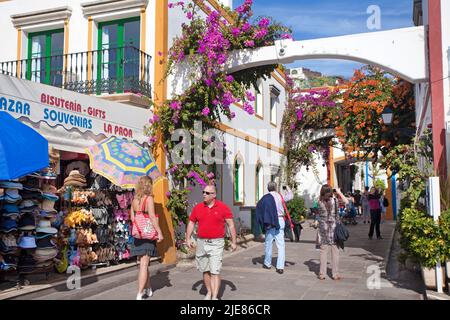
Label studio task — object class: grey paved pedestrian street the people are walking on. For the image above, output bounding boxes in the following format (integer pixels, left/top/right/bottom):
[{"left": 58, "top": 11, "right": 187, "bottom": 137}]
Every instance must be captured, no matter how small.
[{"left": 9, "top": 218, "right": 423, "bottom": 300}]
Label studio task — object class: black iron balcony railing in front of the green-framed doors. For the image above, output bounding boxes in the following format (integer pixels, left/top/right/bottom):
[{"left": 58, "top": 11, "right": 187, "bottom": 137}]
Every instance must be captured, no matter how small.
[{"left": 0, "top": 46, "right": 151, "bottom": 98}]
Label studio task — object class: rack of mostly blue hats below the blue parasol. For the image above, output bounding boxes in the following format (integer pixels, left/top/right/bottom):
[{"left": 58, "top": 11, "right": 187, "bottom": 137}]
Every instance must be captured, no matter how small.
[{"left": 0, "top": 167, "right": 59, "bottom": 289}]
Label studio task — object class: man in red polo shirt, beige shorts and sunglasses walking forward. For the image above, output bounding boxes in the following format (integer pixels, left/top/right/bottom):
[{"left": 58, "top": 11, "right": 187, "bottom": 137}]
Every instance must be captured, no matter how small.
[{"left": 186, "top": 185, "right": 237, "bottom": 300}]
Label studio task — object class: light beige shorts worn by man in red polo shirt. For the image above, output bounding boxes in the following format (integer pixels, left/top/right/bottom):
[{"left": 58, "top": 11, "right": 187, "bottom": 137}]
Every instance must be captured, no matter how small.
[{"left": 195, "top": 238, "right": 225, "bottom": 274}]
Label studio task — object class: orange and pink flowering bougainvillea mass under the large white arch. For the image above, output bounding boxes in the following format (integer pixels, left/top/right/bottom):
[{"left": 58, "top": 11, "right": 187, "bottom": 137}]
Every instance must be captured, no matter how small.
[{"left": 282, "top": 67, "right": 415, "bottom": 182}]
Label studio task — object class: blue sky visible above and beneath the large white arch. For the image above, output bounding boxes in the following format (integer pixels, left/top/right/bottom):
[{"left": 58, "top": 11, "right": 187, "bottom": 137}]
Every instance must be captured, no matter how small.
[{"left": 233, "top": 0, "right": 413, "bottom": 77}]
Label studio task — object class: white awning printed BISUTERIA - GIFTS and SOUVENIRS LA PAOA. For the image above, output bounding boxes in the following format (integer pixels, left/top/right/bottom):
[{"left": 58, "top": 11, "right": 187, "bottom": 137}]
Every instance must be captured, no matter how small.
[{"left": 0, "top": 74, "right": 151, "bottom": 143}]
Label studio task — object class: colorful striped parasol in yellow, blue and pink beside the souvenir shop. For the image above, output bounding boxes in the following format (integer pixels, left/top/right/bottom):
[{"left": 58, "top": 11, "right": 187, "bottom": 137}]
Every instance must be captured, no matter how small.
[{"left": 86, "top": 137, "right": 162, "bottom": 189}]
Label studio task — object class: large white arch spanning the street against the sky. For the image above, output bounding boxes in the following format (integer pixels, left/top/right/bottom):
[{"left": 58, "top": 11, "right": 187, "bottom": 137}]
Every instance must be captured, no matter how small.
[{"left": 227, "top": 26, "right": 428, "bottom": 83}]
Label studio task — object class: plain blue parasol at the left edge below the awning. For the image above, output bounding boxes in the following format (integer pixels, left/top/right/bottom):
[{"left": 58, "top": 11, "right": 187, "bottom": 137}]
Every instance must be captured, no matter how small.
[{"left": 0, "top": 112, "right": 49, "bottom": 180}]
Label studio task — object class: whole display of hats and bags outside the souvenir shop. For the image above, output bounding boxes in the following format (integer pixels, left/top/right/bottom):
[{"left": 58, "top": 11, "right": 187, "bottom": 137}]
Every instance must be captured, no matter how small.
[{"left": 0, "top": 148, "right": 138, "bottom": 290}]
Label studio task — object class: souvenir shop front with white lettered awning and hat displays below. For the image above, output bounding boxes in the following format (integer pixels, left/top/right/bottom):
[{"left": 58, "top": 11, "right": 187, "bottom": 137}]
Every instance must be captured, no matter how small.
[{"left": 0, "top": 75, "right": 151, "bottom": 284}]
